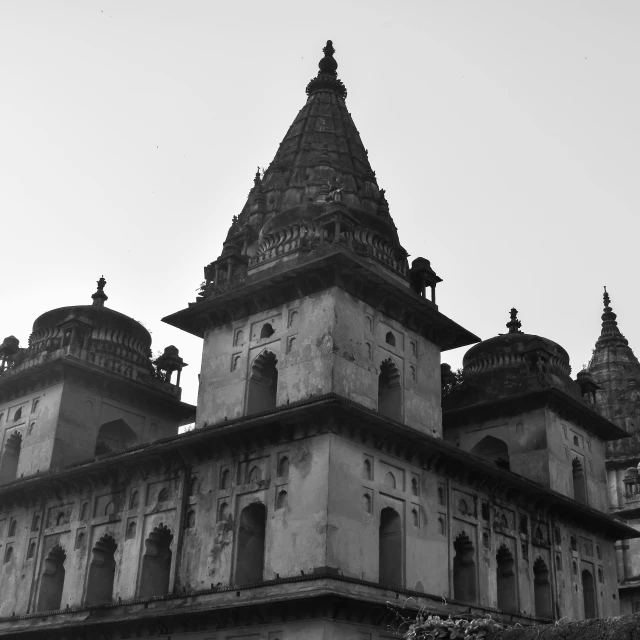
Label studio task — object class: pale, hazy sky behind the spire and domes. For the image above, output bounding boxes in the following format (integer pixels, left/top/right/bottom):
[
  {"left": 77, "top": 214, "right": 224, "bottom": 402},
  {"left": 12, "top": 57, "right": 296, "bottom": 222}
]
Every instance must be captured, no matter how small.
[{"left": 0, "top": 0, "right": 640, "bottom": 403}]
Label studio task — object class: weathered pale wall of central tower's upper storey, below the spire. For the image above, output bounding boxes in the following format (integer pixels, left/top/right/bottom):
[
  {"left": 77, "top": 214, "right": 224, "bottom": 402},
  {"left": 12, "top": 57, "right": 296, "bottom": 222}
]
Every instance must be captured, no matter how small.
[{"left": 196, "top": 287, "right": 442, "bottom": 436}]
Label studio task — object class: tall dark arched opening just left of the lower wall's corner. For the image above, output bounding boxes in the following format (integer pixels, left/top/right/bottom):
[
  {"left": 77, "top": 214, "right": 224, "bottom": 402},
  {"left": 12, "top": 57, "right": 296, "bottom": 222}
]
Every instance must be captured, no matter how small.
[{"left": 234, "top": 502, "right": 267, "bottom": 584}]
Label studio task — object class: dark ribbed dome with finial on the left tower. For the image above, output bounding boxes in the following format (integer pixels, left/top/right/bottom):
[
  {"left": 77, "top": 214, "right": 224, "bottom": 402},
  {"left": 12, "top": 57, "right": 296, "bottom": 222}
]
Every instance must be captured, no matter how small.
[{"left": 29, "top": 278, "right": 151, "bottom": 358}]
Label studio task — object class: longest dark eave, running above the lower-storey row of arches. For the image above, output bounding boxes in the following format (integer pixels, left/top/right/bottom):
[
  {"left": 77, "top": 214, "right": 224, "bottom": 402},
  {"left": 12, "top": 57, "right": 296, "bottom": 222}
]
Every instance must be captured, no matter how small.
[{"left": 0, "top": 393, "right": 640, "bottom": 540}]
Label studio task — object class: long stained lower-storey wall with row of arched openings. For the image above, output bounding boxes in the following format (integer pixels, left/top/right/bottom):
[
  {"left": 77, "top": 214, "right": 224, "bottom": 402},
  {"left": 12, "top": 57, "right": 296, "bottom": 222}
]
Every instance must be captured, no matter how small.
[{"left": 0, "top": 434, "right": 618, "bottom": 619}]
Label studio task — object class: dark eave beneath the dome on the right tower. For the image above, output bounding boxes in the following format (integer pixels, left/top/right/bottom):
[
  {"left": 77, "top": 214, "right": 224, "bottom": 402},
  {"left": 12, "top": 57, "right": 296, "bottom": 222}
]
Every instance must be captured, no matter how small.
[{"left": 442, "top": 387, "right": 629, "bottom": 440}]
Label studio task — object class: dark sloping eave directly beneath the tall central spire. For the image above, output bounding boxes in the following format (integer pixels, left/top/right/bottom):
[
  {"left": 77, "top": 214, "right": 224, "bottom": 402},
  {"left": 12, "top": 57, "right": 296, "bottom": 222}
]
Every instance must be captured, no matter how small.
[{"left": 162, "top": 244, "right": 480, "bottom": 351}]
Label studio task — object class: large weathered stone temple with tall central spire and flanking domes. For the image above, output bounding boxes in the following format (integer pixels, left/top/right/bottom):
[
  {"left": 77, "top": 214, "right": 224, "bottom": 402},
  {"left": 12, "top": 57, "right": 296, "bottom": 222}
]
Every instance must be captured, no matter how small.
[{"left": 0, "top": 41, "right": 640, "bottom": 640}]
